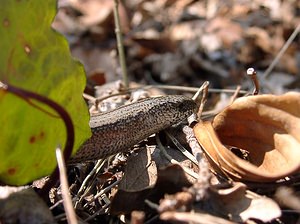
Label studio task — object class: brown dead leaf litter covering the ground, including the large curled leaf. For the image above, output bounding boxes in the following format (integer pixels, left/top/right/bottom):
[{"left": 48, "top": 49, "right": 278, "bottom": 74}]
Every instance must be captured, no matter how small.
[{"left": 1, "top": 0, "right": 300, "bottom": 223}]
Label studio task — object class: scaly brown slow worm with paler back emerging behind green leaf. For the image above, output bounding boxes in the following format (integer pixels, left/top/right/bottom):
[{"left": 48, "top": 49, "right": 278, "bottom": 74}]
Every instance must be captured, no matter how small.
[{"left": 69, "top": 95, "right": 196, "bottom": 163}]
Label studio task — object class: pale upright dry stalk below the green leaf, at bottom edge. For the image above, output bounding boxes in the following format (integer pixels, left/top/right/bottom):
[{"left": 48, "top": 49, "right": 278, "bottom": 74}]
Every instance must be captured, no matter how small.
[{"left": 56, "top": 147, "right": 78, "bottom": 224}]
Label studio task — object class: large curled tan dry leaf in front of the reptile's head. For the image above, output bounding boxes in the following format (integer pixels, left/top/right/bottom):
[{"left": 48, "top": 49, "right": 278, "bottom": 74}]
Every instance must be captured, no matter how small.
[{"left": 194, "top": 92, "right": 300, "bottom": 182}]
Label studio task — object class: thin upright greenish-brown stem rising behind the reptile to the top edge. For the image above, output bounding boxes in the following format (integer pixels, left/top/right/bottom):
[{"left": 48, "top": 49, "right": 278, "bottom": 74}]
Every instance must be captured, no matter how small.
[{"left": 114, "top": 0, "right": 129, "bottom": 89}]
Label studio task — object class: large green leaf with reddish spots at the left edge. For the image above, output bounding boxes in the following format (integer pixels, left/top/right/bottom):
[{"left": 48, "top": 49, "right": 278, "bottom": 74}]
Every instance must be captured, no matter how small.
[{"left": 0, "top": 0, "right": 91, "bottom": 185}]
